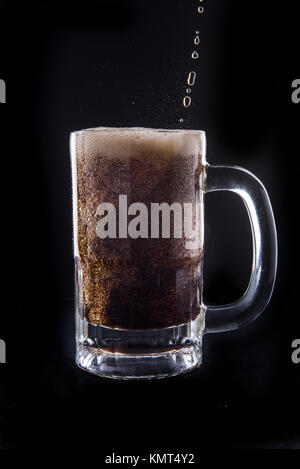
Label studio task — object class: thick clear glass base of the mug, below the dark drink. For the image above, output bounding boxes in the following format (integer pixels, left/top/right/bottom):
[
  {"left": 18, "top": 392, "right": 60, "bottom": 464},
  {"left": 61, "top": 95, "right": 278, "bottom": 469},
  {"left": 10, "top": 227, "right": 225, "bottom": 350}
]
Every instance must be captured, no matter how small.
[{"left": 76, "top": 309, "right": 204, "bottom": 379}]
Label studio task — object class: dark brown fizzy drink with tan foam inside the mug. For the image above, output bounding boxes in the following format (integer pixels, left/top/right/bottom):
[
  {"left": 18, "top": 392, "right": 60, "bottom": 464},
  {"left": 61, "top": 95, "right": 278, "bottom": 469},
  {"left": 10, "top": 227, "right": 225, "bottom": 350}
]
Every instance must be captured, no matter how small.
[{"left": 76, "top": 129, "right": 203, "bottom": 329}]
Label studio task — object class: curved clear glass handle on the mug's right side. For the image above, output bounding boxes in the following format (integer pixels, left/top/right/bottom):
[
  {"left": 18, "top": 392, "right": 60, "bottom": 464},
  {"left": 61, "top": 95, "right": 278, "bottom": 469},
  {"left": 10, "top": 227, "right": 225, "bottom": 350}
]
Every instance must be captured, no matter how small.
[{"left": 204, "top": 164, "right": 277, "bottom": 333}]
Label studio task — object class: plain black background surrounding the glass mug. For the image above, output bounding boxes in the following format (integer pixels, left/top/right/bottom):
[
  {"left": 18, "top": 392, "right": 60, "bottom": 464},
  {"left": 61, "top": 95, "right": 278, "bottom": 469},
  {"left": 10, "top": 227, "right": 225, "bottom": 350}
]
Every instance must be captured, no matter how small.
[{"left": 0, "top": 0, "right": 300, "bottom": 450}]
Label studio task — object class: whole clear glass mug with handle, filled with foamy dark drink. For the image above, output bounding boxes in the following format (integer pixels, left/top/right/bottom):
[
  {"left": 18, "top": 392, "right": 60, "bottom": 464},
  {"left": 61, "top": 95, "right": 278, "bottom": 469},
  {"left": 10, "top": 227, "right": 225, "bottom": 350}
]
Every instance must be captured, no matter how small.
[{"left": 71, "top": 127, "right": 277, "bottom": 379}]
